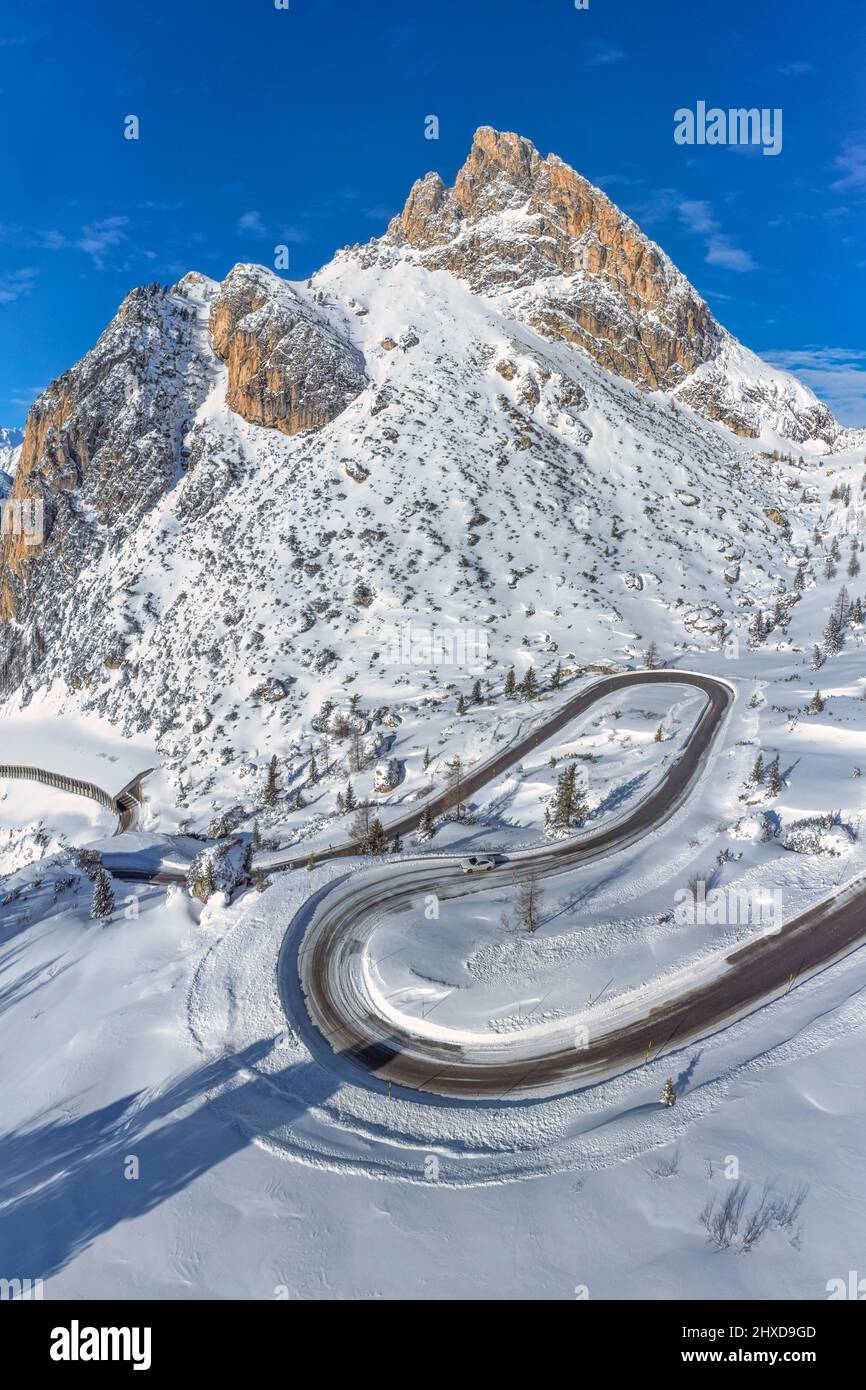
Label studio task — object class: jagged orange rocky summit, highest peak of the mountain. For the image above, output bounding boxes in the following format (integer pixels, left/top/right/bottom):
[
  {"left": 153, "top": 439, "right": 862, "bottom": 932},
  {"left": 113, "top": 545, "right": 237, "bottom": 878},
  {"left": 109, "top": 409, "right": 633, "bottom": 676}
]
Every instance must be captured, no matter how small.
[{"left": 385, "top": 126, "right": 841, "bottom": 446}]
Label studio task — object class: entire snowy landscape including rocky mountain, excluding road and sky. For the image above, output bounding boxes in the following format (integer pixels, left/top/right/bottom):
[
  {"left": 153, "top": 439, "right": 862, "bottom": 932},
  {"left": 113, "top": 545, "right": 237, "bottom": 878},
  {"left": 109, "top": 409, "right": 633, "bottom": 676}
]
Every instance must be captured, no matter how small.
[{"left": 0, "top": 132, "right": 866, "bottom": 1300}]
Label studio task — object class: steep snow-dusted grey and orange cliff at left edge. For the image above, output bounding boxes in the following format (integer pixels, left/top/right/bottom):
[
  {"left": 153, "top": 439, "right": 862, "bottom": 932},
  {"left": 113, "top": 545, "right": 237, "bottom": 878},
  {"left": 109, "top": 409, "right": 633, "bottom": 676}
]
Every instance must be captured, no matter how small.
[{"left": 0, "top": 277, "right": 210, "bottom": 691}]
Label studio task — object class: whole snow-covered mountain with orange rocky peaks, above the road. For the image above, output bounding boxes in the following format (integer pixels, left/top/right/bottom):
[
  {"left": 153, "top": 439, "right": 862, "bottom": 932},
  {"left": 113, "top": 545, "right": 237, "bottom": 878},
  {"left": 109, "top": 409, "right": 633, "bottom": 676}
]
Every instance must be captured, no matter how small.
[{"left": 0, "top": 131, "right": 856, "bottom": 817}]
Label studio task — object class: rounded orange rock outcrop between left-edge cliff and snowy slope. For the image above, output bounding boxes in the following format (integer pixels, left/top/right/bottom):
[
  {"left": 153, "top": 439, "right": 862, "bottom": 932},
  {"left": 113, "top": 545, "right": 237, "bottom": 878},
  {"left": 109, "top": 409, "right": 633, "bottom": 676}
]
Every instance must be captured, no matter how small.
[{"left": 210, "top": 265, "right": 367, "bottom": 435}]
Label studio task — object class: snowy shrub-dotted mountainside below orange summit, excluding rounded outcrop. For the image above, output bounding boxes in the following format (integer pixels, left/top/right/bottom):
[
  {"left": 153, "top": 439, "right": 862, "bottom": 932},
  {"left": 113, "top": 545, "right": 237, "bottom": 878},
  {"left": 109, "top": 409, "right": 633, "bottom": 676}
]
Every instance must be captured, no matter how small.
[{"left": 0, "top": 252, "right": 822, "bottom": 811}]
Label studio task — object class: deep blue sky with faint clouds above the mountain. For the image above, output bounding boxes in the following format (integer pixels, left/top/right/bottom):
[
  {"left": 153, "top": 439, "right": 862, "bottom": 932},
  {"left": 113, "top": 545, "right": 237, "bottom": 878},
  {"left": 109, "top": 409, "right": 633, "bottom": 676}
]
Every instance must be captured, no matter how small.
[{"left": 0, "top": 0, "right": 866, "bottom": 424}]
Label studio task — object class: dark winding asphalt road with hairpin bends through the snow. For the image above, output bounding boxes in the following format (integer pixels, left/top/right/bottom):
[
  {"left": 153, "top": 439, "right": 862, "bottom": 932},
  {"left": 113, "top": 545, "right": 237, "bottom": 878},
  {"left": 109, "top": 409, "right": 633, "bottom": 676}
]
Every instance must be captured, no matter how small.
[{"left": 278, "top": 671, "right": 866, "bottom": 1099}]
